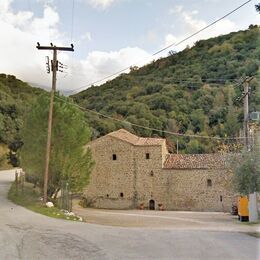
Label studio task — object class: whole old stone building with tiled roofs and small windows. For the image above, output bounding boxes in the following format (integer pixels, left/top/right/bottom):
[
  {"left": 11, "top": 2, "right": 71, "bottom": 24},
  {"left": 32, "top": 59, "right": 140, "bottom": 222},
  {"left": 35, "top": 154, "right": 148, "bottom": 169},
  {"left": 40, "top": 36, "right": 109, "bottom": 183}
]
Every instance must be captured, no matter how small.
[{"left": 84, "top": 129, "right": 234, "bottom": 211}]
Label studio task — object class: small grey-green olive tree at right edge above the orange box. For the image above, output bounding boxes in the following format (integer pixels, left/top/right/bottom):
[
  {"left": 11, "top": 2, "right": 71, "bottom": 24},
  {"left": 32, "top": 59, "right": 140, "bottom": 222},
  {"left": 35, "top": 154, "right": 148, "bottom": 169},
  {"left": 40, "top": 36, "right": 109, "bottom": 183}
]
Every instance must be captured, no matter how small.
[{"left": 233, "top": 151, "right": 260, "bottom": 195}]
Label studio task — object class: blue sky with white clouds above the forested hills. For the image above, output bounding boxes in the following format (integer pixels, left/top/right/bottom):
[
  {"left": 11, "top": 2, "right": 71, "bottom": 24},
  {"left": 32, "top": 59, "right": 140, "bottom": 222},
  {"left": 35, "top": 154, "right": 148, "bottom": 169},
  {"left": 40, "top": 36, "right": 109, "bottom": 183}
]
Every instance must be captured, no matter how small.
[{"left": 0, "top": 0, "right": 260, "bottom": 95}]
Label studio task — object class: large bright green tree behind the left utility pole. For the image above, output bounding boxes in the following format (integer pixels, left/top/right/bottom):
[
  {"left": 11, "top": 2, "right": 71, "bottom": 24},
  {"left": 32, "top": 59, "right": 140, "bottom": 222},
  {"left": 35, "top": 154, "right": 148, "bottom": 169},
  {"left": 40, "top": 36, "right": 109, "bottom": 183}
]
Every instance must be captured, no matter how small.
[{"left": 21, "top": 95, "right": 93, "bottom": 196}]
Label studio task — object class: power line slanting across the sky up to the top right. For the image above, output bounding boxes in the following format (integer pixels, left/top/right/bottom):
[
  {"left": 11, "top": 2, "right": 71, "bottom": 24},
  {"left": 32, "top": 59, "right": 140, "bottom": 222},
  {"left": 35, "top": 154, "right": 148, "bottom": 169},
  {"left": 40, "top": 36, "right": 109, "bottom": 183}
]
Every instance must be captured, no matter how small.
[{"left": 64, "top": 0, "right": 252, "bottom": 93}]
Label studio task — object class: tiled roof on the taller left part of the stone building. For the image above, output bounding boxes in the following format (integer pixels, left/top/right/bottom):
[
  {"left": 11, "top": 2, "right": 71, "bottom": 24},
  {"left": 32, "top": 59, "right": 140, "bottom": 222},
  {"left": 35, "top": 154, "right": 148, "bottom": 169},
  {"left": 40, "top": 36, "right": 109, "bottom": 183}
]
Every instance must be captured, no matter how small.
[{"left": 108, "top": 129, "right": 165, "bottom": 146}]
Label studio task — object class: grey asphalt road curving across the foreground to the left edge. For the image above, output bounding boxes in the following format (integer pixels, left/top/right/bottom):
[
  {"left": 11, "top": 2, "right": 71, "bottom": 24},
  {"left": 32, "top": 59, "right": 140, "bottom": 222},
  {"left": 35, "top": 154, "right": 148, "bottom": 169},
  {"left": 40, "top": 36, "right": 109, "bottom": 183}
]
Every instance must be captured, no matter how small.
[{"left": 0, "top": 171, "right": 260, "bottom": 260}]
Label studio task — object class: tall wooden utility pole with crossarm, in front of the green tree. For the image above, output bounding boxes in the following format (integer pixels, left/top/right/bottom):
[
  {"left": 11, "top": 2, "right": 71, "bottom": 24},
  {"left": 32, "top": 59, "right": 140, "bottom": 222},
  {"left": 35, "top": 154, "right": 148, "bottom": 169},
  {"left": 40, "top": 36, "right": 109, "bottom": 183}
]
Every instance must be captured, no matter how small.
[{"left": 36, "top": 42, "right": 74, "bottom": 203}]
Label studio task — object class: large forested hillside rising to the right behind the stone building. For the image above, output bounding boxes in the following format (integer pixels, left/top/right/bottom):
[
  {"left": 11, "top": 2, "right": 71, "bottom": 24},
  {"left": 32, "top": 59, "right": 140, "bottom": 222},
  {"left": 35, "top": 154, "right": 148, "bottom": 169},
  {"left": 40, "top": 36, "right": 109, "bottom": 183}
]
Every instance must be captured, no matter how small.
[{"left": 73, "top": 25, "right": 260, "bottom": 153}]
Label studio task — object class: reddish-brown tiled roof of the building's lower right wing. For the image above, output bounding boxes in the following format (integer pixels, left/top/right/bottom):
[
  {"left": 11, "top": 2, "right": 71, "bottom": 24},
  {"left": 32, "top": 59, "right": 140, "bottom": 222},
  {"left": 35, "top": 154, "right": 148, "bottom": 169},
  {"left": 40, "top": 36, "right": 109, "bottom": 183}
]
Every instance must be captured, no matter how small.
[{"left": 164, "top": 154, "right": 229, "bottom": 169}]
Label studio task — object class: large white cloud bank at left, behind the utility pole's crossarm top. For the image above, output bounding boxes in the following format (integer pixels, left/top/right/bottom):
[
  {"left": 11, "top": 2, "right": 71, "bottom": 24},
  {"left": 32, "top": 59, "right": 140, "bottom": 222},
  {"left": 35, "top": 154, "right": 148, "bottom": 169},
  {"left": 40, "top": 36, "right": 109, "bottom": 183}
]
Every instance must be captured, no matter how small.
[{"left": 0, "top": 0, "right": 150, "bottom": 91}]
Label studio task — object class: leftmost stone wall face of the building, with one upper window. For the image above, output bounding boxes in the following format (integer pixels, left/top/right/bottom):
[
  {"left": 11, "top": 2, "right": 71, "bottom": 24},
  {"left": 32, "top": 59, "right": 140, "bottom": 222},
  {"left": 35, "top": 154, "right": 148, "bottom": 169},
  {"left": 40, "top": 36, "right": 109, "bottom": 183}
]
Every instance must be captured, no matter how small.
[{"left": 84, "top": 136, "right": 134, "bottom": 209}]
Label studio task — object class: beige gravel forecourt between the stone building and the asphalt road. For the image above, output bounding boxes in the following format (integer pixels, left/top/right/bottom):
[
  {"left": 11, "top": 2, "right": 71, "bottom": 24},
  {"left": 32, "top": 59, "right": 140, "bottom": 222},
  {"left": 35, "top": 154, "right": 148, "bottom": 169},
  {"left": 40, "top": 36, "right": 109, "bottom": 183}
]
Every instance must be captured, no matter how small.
[{"left": 73, "top": 201, "right": 260, "bottom": 233}]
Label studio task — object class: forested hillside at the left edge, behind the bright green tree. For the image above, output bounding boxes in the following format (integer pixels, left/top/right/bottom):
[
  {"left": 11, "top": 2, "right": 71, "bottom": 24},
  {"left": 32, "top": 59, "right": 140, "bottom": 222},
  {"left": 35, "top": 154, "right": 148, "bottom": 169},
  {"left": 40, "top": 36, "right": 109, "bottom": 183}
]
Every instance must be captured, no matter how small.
[{"left": 0, "top": 74, "right": 44, "bottom": 167}]
